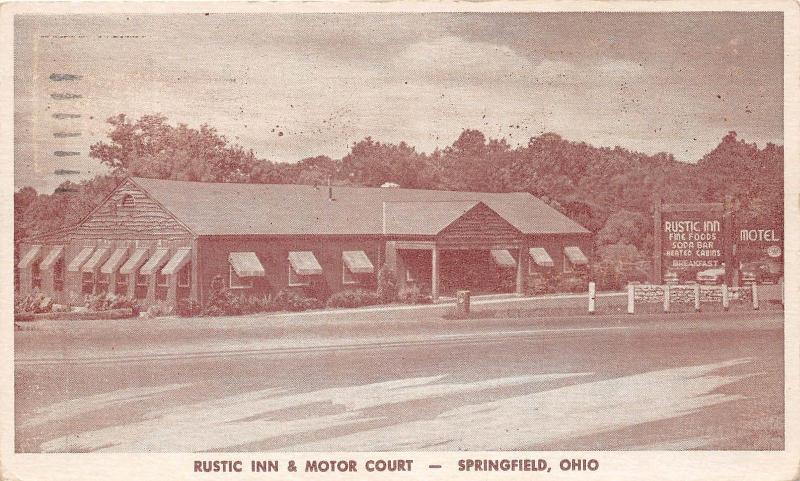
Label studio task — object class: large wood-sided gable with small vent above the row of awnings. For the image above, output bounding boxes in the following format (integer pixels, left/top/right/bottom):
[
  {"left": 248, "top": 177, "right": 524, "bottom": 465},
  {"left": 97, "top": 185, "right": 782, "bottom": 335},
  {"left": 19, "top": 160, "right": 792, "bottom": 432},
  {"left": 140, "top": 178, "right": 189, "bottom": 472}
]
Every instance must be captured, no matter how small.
[{"left": 70, "top": 181, "right": 191, "bottom": 240}]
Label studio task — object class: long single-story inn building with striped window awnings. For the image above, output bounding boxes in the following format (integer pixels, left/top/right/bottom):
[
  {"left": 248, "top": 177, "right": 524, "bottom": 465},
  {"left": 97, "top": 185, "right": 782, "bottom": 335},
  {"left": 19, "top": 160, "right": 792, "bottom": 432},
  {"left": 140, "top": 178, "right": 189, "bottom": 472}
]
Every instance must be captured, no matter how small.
[{"left": 17, "top": 178, "right": 592, "bottom": 305}]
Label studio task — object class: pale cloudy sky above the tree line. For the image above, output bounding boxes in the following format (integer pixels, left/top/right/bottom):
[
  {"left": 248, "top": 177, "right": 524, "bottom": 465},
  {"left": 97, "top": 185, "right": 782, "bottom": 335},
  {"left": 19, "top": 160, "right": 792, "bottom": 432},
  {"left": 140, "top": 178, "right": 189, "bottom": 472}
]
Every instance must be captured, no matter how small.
[{"left": 14, "top": 12, "right": 783, "bottom": 192}]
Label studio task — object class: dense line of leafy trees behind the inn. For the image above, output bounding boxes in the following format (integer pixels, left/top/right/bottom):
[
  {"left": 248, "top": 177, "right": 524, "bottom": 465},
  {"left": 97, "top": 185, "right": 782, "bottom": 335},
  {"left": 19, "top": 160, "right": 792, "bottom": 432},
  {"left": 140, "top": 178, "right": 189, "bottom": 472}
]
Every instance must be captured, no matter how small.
[{"left": 14, "top": 114, "right": 783, "bottom": 266}]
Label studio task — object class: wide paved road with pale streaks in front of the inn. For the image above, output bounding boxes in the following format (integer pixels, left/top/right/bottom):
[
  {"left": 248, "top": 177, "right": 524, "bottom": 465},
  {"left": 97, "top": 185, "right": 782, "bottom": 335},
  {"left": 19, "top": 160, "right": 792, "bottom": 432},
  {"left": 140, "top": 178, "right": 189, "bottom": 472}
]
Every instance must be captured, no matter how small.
[{"left": 15, "top": 309, "right": 783, "bottom": 452}]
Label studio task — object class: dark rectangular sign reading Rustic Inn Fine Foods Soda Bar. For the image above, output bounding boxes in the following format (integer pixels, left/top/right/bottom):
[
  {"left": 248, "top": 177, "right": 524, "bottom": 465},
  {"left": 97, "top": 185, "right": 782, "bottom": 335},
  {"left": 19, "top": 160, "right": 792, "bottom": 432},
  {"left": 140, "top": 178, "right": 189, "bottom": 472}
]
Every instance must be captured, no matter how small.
[{"left": 653, "top": 199, "right": 735, "bottom": 285}]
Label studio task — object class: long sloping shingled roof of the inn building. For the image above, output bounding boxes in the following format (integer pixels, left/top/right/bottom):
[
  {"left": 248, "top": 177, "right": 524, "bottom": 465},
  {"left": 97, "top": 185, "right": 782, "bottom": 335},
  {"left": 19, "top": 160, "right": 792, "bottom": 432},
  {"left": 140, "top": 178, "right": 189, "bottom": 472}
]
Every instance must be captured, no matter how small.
[{"left": 131, "top": 177, "right": 589, "bottom": 236}]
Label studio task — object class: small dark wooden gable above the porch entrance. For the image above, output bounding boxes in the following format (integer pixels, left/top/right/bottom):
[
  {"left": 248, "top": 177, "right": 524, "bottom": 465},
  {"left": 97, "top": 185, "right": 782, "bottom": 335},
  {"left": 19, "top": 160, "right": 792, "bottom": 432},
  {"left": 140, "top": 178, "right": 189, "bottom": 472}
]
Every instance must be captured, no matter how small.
[{"left": 436, "top": 203, "right": 523, "bottom": 247}]
